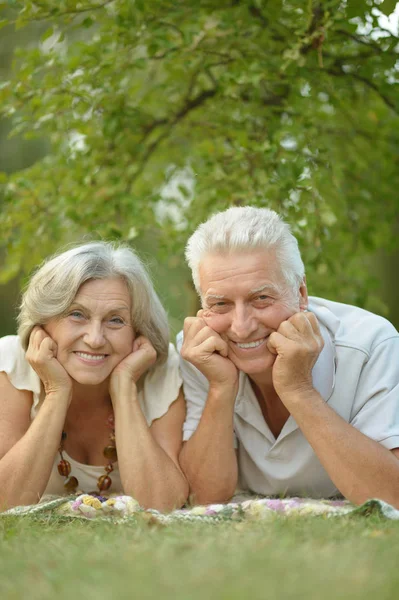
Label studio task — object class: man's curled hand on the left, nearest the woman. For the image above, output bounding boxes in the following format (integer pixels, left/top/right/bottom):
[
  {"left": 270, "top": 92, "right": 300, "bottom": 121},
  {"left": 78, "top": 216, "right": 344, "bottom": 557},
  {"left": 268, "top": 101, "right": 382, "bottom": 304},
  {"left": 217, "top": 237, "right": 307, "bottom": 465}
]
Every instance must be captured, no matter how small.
[{"left": 181, "top": 310, "right": 238, "bottom": 393}]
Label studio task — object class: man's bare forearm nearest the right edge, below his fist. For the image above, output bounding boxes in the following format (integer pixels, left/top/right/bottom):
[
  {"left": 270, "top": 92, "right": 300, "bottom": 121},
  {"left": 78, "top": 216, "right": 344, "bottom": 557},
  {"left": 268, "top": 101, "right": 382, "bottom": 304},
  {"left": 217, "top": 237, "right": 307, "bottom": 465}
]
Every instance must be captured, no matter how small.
[{"left": 282, "top": 390, "right": 399, "bottom": 508}]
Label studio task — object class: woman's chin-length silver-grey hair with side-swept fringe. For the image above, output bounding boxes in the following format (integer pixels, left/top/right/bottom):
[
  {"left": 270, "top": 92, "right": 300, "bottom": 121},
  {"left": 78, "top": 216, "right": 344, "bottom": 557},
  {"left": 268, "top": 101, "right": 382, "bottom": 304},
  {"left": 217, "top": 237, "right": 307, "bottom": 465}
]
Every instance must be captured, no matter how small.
[{"left": 18, "top": 242, "right": 169, "bottom": 363}]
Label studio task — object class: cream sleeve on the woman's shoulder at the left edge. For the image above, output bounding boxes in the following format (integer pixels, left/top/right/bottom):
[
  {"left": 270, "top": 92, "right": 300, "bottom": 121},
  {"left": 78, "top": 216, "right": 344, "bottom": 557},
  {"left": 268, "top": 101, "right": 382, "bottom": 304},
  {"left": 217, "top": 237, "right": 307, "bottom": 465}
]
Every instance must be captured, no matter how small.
[{"left": 0, "top": 335, "right": 40, "bottom": 393}]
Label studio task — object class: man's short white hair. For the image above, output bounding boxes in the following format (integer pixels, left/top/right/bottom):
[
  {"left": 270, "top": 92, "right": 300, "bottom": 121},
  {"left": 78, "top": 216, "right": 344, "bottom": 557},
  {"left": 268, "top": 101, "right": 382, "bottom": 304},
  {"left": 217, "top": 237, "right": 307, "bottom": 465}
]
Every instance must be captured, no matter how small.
[{"left": 186, "top": 206, "right": 305, "bottom": 295}]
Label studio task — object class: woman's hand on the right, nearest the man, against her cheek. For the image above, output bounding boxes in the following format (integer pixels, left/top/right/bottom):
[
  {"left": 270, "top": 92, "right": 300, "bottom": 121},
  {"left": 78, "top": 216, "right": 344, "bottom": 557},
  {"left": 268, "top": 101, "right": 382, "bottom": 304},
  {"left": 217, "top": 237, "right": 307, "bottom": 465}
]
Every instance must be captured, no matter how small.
[{"left": 109, "top": 335, "right": 157, "bottom": 399}]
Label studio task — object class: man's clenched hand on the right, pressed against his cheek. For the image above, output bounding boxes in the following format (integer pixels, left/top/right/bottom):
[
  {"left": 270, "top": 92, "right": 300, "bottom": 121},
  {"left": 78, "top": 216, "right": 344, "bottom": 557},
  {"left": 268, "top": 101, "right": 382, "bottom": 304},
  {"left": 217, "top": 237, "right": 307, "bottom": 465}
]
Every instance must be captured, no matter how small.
[{"left": 267, "top": 312, "right": 324, "bottom": 403}]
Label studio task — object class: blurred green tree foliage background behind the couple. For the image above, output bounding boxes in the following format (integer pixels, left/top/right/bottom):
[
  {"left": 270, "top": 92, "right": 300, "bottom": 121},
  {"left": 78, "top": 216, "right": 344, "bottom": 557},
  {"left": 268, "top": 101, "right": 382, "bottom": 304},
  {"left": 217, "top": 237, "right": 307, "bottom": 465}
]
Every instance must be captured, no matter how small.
[{"left": 0, "top": 0, "right": 399, "bottom": 334}]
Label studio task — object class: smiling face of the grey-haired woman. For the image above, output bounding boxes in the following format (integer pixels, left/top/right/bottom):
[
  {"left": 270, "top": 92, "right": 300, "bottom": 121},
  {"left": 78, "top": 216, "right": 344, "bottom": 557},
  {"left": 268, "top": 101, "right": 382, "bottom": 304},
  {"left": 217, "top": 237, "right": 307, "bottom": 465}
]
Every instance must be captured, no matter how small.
[{"left": 44, "top": 277, "right": 135, "bottom": 385}]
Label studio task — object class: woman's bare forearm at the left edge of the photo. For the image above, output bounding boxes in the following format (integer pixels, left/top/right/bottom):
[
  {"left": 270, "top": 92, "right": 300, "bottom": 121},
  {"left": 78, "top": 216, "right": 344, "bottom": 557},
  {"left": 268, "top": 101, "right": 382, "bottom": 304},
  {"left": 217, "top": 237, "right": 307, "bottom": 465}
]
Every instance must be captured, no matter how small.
[{"left": 0, "top": 393, "right": 69, "bottom": 511}]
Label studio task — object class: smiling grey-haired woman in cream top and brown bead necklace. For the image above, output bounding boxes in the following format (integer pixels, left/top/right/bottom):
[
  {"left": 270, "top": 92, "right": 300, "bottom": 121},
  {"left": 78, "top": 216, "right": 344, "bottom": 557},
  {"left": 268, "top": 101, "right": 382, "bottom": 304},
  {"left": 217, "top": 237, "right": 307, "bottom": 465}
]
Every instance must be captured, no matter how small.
[{"left": 0, "top": 242, "right": 188, "bottom": 510}]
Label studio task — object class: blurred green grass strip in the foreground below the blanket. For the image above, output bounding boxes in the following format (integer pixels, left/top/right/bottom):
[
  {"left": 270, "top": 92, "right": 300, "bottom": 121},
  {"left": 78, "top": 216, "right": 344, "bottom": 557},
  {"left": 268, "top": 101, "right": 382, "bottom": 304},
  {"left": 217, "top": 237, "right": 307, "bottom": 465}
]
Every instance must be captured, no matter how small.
[{"left": 0, "top": 517, "right": 399, "bottom": 600}]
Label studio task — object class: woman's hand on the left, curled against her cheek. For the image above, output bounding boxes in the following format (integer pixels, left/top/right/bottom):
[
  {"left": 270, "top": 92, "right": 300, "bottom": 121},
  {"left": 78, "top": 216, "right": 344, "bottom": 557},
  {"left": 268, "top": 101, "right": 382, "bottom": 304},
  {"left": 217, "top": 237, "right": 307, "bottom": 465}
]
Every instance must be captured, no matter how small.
[{"left": 26, "top": 325, "right": 72, "bottom": 396}]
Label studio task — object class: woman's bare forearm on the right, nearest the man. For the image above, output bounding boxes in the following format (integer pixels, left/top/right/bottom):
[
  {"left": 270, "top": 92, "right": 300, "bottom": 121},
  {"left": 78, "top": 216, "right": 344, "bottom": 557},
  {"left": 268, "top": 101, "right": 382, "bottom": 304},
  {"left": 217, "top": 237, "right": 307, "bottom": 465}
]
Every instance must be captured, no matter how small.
[{"left": 114, "top": 392, "right": 188, "bottom": 510}]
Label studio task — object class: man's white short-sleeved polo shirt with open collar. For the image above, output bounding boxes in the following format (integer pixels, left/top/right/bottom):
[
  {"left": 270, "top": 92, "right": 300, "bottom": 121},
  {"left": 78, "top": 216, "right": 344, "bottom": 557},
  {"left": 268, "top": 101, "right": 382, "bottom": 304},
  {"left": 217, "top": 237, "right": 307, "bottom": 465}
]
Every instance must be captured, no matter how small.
[{"left": 177, "top": 297, "right": 399, "bottom": 498}]
